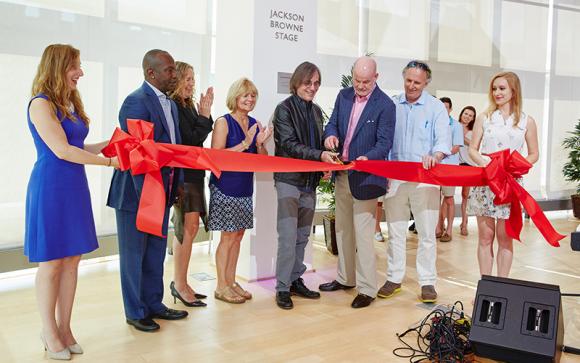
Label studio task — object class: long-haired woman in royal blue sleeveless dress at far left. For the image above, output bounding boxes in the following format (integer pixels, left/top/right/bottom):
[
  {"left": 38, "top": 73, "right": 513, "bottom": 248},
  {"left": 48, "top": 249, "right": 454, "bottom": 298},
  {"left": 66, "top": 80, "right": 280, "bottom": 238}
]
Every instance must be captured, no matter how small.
[{"left": 24, "top": 44, "right": 119, "bottom": 360}]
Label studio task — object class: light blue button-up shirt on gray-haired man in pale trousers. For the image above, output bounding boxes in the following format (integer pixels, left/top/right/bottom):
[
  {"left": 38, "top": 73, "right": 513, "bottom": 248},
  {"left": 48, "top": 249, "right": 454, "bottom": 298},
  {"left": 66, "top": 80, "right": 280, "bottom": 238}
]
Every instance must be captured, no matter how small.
[{"left": 389, "top": 91, "right": 451, "bottom": 162}]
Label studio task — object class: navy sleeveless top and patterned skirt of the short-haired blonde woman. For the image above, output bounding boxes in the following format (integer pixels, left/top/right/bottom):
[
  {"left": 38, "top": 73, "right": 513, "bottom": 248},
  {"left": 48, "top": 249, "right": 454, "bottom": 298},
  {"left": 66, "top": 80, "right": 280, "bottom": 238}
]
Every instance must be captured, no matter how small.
[{"left": 208, "top": 114, "right": 258, "bottom": 232}]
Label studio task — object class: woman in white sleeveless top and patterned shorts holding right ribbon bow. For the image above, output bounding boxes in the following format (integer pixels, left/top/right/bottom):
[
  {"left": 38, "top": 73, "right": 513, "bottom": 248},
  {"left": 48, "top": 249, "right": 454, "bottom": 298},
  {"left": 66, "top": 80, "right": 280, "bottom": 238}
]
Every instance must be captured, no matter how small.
[{"left": 467, "top": 72, "right": 539, "bottom": 277}]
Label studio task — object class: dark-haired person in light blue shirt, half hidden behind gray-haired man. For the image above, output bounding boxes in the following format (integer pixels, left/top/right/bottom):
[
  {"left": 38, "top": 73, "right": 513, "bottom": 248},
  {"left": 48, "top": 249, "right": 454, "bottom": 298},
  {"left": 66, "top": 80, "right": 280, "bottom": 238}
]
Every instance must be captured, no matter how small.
[{"left": 435, "top": 97, "right": 463, "bottom": 242}]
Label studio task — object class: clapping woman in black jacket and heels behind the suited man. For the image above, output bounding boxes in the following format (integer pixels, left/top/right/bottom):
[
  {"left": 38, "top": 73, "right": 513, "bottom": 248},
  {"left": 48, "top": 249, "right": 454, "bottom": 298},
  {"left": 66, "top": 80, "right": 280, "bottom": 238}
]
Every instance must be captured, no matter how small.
[{"left": 169, "top": 62, "right": 213, "bottom": 307}]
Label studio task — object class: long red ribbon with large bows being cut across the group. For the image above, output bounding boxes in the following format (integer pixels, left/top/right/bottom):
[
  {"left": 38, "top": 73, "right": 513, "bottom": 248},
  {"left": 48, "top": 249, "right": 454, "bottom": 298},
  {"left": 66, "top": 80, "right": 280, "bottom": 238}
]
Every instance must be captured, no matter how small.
[{"left": 103, "top": 119, "right": 565, "bottom": 246}]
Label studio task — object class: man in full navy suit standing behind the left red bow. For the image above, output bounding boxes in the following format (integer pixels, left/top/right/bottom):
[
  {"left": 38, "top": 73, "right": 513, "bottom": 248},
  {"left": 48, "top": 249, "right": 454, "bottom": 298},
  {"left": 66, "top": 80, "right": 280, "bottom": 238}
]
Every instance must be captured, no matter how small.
[{"left": 107, "top": 49, "right": 187, "bottom": 332}]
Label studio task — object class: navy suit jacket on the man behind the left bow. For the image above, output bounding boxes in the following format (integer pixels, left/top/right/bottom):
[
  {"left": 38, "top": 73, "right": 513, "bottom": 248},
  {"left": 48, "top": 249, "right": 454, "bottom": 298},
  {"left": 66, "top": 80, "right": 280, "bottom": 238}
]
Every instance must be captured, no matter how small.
[{"left": 107, "top": 82, "right": 182, "bottom": 219}]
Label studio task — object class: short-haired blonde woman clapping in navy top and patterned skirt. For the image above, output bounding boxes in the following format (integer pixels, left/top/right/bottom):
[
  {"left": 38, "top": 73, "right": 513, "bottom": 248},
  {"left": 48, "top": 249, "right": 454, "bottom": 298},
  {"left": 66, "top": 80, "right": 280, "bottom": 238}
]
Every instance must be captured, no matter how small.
[{"left": 208, "top": 78, "right": 272, "bottom": 304}]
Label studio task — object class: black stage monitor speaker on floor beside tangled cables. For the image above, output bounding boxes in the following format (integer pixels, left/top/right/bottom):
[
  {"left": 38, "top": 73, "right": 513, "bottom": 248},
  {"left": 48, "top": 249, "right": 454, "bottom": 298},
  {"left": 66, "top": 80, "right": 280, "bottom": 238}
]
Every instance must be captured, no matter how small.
[{"left": 469, "top": 276, "right": 564, "bottom": 363}]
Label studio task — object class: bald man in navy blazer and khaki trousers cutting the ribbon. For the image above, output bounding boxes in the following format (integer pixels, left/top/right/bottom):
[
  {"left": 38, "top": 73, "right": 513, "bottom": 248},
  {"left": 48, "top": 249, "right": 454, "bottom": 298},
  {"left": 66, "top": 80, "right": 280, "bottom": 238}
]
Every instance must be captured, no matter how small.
[{"left": 319, "top": 57, "right": 396, "bottom": 308}]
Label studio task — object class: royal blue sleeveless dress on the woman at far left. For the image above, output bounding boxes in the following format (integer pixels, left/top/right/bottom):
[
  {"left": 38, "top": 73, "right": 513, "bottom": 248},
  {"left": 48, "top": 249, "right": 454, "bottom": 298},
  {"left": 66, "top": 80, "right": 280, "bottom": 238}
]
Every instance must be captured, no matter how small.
[{"left": 24, "top": 94, "right": 99, "bottom": 262}]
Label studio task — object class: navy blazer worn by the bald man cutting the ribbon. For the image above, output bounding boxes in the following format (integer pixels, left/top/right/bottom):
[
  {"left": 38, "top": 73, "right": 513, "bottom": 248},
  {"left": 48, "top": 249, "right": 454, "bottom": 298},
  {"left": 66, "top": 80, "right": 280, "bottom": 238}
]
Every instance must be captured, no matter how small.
[{"left": 324, "top": 86, "right": 396, "bottom": 200}]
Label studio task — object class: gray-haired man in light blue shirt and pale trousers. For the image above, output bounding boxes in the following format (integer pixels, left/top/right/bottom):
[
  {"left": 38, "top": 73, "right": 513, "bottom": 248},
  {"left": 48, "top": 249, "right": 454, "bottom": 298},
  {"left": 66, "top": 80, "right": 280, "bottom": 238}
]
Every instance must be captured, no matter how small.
[{"left": 378, "top": 60, "right": 451, "bottom": 302}]
